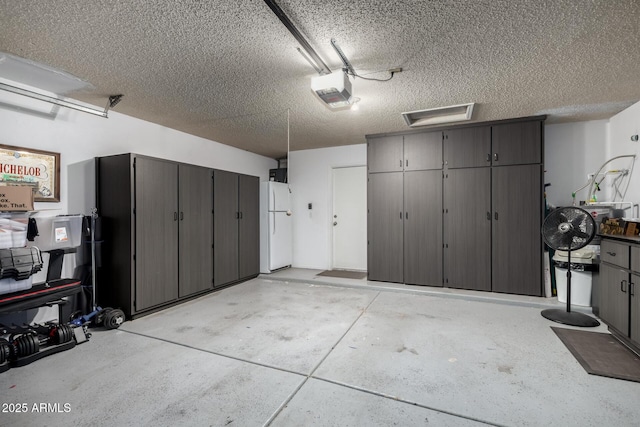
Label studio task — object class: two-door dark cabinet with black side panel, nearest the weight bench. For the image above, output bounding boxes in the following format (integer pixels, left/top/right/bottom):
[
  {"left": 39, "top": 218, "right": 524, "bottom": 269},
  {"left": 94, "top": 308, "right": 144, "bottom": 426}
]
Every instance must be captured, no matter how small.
[{"left": 96, "top": 154, "right": 213, "bottom": 317}]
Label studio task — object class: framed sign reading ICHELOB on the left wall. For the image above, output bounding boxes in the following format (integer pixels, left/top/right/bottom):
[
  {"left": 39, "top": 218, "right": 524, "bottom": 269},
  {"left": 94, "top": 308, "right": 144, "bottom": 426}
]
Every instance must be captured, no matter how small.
[{"left": 0, "top": 145, "right": 60, "bottom": 202}]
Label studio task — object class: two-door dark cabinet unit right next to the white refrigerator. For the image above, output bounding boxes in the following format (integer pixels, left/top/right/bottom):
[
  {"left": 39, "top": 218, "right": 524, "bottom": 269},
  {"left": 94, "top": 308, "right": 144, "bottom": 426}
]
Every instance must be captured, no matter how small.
[{"left": 213, "top": 170, "right": 260, "bottom": 287}]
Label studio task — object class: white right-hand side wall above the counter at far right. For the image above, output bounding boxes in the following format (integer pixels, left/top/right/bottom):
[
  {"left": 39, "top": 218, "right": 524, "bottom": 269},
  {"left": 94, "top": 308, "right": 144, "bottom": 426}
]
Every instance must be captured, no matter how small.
[{"left": 607, "top": 102, "right": 640, "bottom": 217}]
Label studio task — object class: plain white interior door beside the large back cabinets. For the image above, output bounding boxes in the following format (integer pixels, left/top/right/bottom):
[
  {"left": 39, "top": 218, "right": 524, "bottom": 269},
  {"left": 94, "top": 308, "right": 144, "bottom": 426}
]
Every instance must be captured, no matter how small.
[{"left": 331, "top": 166, "right": 367, "bottom": 271}]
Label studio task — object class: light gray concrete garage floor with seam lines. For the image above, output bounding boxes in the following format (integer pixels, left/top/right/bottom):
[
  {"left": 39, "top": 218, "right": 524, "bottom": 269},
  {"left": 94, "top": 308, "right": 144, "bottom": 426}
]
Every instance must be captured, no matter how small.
[{"left": 0, "top": 269, "right": 640, "bottom": 426}]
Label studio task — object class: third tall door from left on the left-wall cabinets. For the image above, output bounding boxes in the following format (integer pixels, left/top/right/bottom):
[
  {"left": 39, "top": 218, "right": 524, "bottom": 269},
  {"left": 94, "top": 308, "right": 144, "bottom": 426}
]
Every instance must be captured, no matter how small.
[{"left": 213, "top": 170, "right": 239, "bottom": 287}]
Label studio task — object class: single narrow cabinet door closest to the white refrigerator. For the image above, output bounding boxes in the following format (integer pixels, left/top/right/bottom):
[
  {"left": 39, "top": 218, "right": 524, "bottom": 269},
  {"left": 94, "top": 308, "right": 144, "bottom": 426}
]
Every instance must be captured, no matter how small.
[{"left": 238, "top": 175, "right": 260, "bottom": 279}]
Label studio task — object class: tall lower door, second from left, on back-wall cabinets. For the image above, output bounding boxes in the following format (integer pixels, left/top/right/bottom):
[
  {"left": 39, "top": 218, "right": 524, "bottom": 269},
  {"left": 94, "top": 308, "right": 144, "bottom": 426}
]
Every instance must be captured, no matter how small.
[{"left": 404, "top": 170, "right": 442, "bottom": 286}]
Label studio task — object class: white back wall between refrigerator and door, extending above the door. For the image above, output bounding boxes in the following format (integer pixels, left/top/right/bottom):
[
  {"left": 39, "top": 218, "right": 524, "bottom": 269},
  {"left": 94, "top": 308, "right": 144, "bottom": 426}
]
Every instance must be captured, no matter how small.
[{"left": 289, "top": 144, "right": 367, "bottom": 270}]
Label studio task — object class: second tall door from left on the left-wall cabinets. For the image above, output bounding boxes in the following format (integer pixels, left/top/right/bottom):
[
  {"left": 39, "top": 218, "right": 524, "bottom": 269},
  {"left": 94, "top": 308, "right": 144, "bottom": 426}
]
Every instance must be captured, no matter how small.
[{"left": 178, "top": 165, "right": 213, "bottom": 297}]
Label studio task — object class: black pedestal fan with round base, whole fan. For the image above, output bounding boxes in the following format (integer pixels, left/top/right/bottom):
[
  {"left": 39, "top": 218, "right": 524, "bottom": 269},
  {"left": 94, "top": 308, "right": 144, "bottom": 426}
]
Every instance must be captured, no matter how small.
[{"left": 541, "top": 206, "right": 600, "bottom": 327}]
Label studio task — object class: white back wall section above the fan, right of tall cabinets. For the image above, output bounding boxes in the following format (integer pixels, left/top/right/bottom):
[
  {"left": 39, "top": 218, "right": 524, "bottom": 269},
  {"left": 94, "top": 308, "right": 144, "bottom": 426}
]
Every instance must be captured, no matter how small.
[{"left": 544, "top": 120, "right": 608, "bottom": 206}]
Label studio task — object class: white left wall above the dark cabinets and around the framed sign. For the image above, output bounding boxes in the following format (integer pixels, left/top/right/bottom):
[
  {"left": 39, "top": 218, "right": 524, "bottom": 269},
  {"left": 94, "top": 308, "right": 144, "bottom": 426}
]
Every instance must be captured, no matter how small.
[{"left": 0, "top": 86, "right": 277, "bottom": 215}]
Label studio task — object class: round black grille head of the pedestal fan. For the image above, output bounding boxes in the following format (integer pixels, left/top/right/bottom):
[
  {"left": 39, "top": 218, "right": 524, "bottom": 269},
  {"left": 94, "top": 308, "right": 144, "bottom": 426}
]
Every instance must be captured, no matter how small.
[{"left": 542, "top": 206, "right": 596, "bottom": 251}]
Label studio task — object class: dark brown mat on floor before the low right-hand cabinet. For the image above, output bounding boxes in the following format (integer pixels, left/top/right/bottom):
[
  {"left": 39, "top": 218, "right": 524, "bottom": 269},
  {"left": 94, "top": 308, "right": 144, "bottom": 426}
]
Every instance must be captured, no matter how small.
[{"left": 551, "top": 326, "right": 640, "bottom": 382}]
